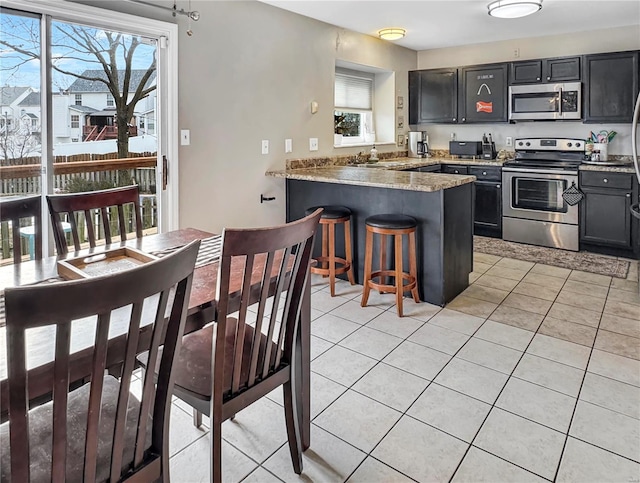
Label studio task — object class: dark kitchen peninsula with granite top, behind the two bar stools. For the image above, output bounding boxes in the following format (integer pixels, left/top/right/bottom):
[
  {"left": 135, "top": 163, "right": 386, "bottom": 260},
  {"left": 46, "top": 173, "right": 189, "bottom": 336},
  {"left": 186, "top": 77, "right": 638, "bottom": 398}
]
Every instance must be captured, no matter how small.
[{"left": 266, "top": 164, "right": 475, "bottom": 306}]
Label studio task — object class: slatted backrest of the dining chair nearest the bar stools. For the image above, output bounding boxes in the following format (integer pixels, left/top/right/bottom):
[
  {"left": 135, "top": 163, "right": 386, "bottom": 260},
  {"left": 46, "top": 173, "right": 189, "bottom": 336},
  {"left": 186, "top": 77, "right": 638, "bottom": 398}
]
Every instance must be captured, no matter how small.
[{"left": 212, "top": 210, "right": 321, "bottom": 402}]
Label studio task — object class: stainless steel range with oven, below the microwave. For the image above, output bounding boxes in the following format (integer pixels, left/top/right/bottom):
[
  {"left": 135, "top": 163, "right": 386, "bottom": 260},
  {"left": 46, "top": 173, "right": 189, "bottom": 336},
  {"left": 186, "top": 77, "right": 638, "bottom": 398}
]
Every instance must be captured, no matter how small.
[{"left": 502, "top": 138, "right": 584, "bottom": 251}]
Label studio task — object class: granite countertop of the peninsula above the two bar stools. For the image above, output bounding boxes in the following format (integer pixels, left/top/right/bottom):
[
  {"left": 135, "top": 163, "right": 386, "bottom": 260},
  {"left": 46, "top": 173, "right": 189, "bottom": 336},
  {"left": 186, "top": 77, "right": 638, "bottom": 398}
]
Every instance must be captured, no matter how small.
[{"left": 265, "top": 166, "right": 476, "bottom": 191}]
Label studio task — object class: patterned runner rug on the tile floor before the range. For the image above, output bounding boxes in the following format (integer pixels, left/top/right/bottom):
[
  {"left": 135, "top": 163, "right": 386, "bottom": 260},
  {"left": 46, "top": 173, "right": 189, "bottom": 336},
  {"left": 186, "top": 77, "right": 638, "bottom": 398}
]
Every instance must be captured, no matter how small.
[{"left": 473, "top": 236, "right": 629, "bottom": 278}]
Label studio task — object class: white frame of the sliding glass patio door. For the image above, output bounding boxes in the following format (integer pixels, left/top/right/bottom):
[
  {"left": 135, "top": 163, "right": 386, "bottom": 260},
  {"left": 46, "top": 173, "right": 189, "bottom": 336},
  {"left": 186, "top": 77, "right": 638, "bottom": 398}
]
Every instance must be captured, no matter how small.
[{"left": 2, "top": 0, "right": 180, "bottom": 232}]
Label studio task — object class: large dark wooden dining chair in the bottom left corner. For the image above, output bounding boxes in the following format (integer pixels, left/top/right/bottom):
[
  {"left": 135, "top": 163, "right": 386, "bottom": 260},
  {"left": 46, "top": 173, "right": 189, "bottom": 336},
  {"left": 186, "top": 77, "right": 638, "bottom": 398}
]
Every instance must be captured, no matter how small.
[{"left": 0, "top": 241, "right": 200, "bottom": 482}]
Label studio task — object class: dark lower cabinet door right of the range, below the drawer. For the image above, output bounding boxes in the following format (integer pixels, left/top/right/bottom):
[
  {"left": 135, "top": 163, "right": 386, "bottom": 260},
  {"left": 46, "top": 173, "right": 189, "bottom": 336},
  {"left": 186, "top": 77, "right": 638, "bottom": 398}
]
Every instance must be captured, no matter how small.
[{"left": 580, "top": 187, "right": 632, "bottom": 248}]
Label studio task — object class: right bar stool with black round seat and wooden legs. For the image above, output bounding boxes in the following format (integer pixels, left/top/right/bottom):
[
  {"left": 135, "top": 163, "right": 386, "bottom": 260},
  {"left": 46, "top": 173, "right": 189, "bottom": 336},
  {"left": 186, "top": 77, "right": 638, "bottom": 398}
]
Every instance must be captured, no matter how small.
[{"left": 360, "top": 214, "right": 420, "bottom": 317}]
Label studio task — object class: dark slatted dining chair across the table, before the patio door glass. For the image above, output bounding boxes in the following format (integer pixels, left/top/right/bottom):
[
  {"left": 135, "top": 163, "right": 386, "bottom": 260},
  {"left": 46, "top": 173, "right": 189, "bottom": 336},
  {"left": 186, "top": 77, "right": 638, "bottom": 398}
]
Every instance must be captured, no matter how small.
[{"left": 47, "top": 185, "right": 142, "bottom": 255}]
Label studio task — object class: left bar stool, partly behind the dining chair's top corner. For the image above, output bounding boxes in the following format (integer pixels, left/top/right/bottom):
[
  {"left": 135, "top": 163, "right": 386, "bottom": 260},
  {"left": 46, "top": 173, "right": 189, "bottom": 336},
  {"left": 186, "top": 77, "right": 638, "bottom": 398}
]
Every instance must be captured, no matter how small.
[{"left": 305, "top": 205, "right": 356, "bottom": 297}]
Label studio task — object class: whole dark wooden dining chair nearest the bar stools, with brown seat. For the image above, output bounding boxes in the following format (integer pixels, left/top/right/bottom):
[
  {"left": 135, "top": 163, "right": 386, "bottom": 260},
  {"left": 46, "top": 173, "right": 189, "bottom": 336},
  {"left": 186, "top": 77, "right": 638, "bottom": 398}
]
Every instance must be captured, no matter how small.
[{"left": 148, "top": 209, "right": 322, "bottom": 483}]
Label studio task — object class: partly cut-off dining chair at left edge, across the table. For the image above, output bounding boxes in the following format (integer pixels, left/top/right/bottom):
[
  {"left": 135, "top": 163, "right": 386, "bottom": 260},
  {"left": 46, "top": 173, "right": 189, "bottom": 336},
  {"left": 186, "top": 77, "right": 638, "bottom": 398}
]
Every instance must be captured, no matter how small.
[{"left": 0, "top": 195, "right": 42, "bottom": 263}]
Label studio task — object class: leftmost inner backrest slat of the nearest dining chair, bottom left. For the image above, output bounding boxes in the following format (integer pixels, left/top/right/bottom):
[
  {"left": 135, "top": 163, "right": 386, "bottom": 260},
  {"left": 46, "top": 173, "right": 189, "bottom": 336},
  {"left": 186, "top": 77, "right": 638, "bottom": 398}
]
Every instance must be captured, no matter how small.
[{"left": 51, "top": 321, "right": 71, "bottom": 481}]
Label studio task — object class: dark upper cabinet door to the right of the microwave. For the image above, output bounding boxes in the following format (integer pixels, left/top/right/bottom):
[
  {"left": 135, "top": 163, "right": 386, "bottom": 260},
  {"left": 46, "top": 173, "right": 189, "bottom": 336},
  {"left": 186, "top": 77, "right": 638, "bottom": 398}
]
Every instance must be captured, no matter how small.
[{"left": 583, "top": 51, "right": 638, "bottom": 123}]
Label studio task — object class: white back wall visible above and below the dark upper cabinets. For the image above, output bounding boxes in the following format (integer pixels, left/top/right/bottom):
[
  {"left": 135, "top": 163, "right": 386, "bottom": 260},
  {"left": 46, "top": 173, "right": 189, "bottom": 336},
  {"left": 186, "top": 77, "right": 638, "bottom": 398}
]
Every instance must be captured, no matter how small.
[{"left": 413, "top": 26, "right": 640, "bottom": 155}]
